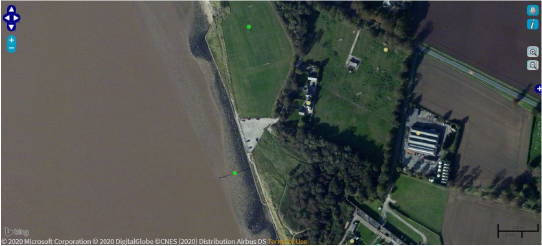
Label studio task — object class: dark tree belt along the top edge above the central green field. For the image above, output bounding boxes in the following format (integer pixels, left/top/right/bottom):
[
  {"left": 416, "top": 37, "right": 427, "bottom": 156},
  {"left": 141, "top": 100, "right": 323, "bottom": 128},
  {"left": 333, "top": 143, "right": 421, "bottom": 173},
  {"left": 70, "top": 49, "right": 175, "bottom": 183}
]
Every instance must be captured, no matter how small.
[{"left": 275, "top": 0, "right": 426, "bottom": 55}]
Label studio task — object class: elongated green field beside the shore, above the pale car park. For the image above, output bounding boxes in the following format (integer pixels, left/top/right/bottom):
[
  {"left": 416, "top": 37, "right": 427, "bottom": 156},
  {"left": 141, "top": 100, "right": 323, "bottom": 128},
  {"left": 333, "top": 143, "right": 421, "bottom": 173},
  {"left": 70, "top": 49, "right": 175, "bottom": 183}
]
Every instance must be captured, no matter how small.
[{"left": 222, "top": 0, "right": 293, "bottom": 117}]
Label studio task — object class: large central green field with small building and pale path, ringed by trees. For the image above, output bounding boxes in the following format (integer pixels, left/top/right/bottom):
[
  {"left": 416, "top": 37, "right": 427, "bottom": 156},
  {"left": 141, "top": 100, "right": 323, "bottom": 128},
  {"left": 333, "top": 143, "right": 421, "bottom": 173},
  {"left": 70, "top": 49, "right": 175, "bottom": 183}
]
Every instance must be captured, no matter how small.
[{"left": 304, "top": 13, "right": 408, "bottom": 154}]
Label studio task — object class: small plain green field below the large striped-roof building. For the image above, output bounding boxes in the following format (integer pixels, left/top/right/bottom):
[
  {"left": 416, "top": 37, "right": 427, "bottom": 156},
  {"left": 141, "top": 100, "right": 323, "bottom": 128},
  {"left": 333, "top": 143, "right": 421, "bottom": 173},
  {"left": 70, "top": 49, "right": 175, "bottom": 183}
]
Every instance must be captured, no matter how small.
[{"left": 391, "top": 175, "right": 448, "bottom": 233}]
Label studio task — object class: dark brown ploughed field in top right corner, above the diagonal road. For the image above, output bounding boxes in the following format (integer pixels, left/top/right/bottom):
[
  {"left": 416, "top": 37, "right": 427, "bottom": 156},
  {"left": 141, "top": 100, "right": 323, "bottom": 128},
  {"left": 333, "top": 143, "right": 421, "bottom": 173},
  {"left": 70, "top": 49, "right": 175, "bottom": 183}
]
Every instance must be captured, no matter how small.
[{"left": 421, "top": 0, "right": 542, "bottom": 99}]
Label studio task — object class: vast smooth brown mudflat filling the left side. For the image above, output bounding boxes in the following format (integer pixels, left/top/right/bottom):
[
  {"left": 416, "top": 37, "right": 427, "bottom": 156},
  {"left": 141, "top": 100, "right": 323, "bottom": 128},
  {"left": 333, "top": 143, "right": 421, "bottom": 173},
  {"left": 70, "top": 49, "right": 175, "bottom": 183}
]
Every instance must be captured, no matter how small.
[{"left": 2, "top": 1, "right": 254, "bottom": 239}]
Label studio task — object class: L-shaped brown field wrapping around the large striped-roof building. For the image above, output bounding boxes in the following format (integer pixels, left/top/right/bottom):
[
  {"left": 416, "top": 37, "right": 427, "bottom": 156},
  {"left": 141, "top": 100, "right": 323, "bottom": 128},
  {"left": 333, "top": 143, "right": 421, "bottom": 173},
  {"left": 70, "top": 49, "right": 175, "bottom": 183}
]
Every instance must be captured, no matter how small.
[{"left": 414, "top": 57, "right": 531, "bottom": 186}]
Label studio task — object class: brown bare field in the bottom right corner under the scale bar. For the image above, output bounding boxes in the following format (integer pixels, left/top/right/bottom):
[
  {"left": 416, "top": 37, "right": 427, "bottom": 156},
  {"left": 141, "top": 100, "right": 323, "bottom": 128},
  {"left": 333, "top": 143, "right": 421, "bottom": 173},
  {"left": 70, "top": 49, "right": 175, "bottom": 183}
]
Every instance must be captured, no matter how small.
[{"left": 442, "top": 191, "right": 542, "bottom": 244}]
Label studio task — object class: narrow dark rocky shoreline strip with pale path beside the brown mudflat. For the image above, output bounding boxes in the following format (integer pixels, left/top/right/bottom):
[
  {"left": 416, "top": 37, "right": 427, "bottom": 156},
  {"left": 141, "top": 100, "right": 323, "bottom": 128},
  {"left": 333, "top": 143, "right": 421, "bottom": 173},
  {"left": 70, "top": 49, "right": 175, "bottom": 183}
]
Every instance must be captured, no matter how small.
[{"left": 190, "top": 0, "right": 277, "bottom": 238}]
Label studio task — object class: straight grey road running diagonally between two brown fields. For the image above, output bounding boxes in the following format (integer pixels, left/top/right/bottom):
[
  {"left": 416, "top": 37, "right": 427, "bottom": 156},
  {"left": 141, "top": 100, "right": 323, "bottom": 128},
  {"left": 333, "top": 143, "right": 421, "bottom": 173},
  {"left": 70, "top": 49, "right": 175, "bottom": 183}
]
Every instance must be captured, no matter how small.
[{"left": 418, "top": 46, "right": 538, "bottom": 107}]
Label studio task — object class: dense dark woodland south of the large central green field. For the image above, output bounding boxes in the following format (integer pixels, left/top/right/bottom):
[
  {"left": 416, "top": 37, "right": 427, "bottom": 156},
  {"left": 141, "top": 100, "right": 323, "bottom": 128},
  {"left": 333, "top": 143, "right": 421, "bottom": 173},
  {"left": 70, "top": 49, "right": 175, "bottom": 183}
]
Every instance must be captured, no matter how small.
[{"left": 273, "top": 122, "right": 381, "bottom": 244}]
